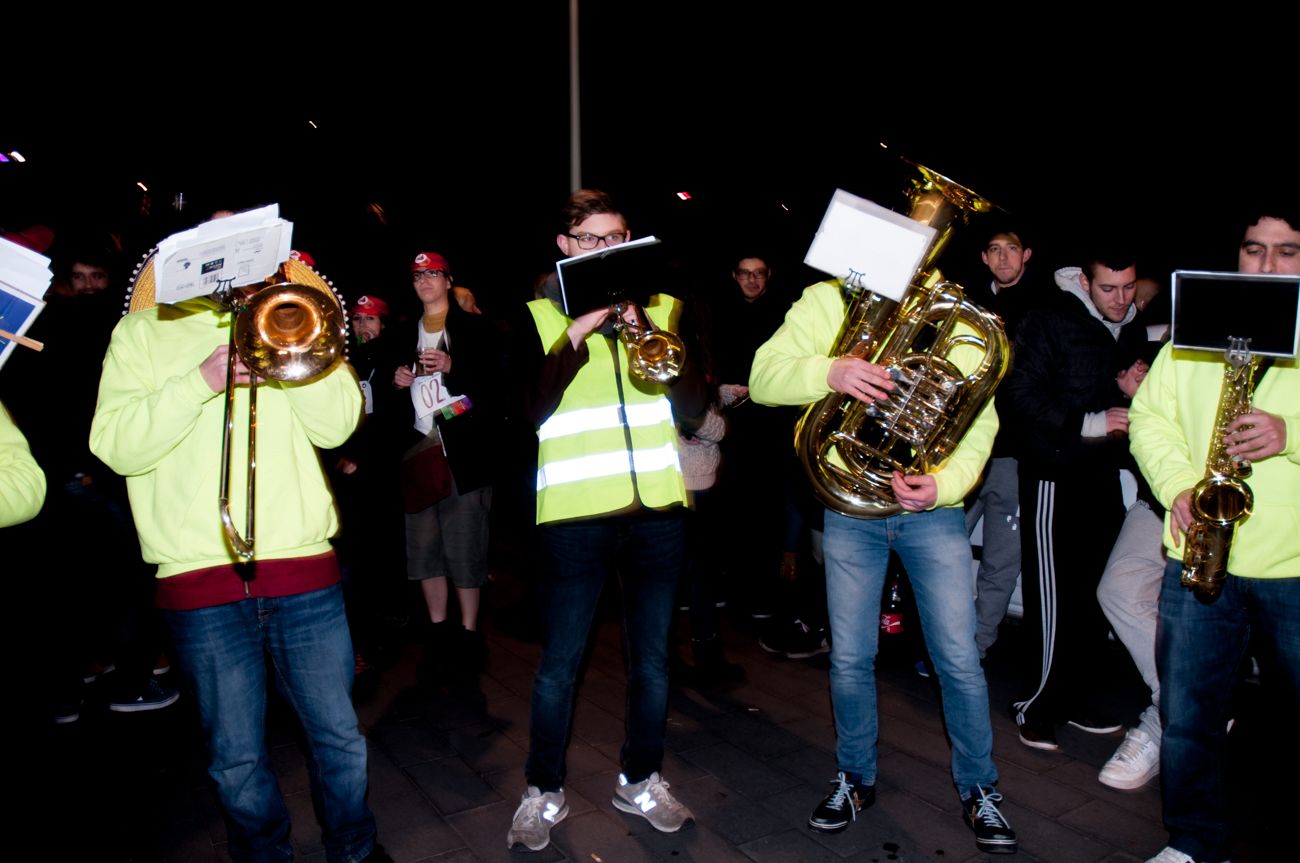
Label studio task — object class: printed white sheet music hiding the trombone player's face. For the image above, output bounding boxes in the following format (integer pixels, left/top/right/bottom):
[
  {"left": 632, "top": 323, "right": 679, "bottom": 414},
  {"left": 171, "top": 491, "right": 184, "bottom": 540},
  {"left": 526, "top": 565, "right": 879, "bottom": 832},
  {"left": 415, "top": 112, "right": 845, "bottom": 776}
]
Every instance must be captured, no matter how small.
[{"left": 153, "top": 204, "right": 294, "bottom": 303}]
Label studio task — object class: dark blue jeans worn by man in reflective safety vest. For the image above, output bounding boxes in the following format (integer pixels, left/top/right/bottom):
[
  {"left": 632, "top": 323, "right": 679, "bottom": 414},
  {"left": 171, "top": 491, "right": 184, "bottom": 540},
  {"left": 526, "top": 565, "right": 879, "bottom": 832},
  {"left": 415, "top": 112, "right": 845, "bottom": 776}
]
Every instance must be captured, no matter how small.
[{"left": 525, "top": 512, "right": 685, "bottom": 792}]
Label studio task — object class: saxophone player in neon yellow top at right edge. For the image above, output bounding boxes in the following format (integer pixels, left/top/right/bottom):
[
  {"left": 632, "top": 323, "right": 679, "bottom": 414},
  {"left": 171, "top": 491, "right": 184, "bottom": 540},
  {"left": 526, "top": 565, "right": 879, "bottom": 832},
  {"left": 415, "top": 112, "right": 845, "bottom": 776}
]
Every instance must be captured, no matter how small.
[{"left": 1128, "top": 207, "right": 1300, "bottom": 863}]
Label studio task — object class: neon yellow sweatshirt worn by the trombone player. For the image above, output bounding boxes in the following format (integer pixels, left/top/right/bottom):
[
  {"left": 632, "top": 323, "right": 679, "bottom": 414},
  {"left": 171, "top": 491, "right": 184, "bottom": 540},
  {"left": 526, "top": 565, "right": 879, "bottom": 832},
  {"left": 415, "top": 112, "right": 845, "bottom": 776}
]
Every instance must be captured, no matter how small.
[{"left": 90, "top": 299, "right": 361, "bottom": 578}]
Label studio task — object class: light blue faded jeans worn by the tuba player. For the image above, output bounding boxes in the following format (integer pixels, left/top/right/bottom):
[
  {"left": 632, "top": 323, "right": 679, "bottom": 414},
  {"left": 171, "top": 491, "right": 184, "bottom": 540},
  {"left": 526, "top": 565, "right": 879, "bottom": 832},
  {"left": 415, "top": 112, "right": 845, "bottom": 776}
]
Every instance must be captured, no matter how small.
[{"left": 824, "top": 507, "right": 997, "bottom": 794}]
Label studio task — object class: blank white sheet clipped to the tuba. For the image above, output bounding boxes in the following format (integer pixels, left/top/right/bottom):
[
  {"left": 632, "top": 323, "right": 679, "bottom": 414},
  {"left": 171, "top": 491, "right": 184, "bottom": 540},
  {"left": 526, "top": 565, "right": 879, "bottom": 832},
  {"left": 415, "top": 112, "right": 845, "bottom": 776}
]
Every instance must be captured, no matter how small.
[{"left": 803, "top": 188, "right": 936, "bottom": 300}]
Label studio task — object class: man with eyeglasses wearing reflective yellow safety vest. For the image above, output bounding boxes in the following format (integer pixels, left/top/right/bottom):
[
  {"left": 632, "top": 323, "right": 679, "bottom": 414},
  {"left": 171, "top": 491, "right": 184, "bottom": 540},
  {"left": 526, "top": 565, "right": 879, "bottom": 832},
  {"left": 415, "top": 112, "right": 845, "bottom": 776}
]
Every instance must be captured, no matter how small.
[{"left": 506, "top": 190, "right": 705, "bottom": 851}]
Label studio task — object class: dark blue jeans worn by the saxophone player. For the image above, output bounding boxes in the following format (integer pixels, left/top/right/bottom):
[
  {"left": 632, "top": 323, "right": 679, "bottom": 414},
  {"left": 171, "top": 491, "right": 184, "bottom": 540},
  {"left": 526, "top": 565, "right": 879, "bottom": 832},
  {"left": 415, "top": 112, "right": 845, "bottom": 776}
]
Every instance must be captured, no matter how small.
[{"left": 1156, "top": 559, "right": 1300, "bottom": 860}]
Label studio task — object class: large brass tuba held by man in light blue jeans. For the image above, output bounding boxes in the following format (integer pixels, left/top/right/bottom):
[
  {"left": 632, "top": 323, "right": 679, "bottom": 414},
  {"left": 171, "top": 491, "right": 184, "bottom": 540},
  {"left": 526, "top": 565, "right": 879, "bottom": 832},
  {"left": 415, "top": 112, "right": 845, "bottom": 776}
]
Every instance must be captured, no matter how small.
[{"left": 794, "top": 162, "right": 1010, "bottom": 519}]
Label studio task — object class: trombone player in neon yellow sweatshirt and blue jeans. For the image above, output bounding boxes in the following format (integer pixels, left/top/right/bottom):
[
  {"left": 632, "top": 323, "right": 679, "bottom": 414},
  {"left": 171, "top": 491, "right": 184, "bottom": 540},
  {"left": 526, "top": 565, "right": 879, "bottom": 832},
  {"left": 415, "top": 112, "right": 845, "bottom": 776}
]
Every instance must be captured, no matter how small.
[{"left": 90, "top": 244, "right": 389, "bottom": 863}]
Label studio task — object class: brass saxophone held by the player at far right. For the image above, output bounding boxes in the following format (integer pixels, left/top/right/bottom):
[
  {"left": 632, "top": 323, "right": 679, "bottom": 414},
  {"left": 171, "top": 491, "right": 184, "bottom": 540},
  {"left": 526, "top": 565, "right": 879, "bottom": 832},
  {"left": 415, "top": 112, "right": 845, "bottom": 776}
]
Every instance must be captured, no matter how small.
[{"left": 1180, "top": 339, "right": 1260, "bottom": 603}]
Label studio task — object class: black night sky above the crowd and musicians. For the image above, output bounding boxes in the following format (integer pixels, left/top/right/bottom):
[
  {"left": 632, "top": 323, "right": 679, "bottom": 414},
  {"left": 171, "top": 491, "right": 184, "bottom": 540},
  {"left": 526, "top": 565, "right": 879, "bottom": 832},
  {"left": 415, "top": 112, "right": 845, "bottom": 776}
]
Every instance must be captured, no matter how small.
[{"left": 0, "top": 6, "right": 1296, "bottom": 313}]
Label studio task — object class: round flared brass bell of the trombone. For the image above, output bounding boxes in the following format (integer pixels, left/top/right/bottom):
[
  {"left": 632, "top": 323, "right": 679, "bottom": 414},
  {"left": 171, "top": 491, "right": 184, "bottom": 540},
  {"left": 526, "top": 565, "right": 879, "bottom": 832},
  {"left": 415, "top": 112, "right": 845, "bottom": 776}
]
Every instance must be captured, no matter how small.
[{"left": 234, "top": 282, "right": 346, "bottom": 381}]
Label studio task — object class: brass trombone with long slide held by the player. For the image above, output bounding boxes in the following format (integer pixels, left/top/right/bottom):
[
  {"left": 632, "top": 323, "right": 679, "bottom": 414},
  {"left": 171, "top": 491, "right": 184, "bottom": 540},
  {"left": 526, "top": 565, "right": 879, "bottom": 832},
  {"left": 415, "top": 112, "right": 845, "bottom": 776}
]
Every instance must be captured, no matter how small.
[{"left": 218, "top": 260, "right": 347, "bottom": 561}]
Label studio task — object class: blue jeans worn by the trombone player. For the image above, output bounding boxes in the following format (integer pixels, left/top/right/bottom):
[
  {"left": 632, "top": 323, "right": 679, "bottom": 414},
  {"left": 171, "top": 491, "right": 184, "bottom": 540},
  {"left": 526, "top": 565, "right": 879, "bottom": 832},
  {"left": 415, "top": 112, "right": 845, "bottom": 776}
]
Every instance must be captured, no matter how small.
[{"left": 166, "top": 585, "right": 374, "bottom": 863}]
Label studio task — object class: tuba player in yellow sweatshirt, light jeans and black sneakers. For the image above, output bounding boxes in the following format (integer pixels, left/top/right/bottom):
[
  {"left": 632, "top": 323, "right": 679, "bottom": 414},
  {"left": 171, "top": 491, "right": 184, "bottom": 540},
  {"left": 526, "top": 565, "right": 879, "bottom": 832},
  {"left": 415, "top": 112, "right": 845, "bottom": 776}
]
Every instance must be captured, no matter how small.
[{"left": 749, "top": 282, "right": 1017, "bottom": 854}]
